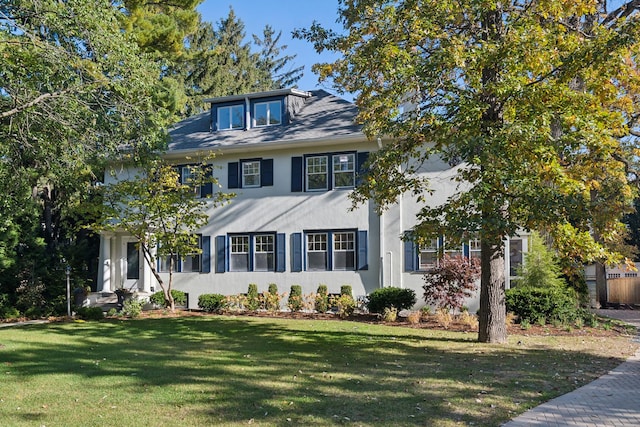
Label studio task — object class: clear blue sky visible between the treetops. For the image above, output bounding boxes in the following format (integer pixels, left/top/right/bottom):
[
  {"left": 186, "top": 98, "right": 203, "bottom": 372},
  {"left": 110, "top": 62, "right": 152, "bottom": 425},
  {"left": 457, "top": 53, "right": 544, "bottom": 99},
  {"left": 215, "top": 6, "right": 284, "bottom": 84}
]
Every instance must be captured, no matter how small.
[{"left": 198, "top": 0, "right": 341, "bottom": 96}]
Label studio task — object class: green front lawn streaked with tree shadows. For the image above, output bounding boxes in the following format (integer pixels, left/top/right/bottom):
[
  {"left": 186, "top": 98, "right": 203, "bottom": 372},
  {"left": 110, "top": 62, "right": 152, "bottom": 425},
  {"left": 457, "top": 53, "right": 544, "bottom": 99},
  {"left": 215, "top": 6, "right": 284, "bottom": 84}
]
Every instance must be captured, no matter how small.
[{"left": 0, "top": 316, "right": 634, "bottom": 427}]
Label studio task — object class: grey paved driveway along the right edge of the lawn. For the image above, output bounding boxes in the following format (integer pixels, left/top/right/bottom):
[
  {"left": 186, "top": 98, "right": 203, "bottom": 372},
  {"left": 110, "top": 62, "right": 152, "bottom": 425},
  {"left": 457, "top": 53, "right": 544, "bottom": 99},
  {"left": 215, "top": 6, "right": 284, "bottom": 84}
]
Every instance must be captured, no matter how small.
[{"left": 503, "top": 310, "right": 640, "bottom": 427}]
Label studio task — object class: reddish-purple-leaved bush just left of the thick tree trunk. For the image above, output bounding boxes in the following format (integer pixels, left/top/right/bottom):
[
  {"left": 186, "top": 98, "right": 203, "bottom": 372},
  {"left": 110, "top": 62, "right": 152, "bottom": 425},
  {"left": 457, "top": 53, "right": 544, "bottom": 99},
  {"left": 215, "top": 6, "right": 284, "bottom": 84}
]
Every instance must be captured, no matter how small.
[{"left": 422, "top": 255, "right": 480, "bottom": 310}]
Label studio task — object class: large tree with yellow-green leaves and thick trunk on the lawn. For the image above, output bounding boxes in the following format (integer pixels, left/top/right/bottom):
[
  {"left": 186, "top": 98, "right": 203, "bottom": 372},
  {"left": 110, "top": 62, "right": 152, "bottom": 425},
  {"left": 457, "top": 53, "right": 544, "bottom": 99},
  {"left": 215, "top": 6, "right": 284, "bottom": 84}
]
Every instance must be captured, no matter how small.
[{"left": 297, "top": 0, "right": 640, "bottom": 342}]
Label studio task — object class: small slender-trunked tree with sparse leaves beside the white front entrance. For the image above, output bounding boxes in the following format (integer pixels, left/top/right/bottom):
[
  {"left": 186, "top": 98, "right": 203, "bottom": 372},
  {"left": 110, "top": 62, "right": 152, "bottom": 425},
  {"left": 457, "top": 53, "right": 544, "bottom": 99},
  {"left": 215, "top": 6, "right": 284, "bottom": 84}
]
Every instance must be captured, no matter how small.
[{"left": 94, "top": 157, "right": 232, "bottom": 311}]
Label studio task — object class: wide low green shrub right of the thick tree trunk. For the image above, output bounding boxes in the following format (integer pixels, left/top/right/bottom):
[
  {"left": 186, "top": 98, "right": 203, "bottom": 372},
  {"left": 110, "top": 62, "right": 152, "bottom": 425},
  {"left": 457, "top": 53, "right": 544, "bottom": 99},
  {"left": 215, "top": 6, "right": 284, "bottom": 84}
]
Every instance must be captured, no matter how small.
[{"left": 505, "top": 286, "right": 580, "bottom": 323}]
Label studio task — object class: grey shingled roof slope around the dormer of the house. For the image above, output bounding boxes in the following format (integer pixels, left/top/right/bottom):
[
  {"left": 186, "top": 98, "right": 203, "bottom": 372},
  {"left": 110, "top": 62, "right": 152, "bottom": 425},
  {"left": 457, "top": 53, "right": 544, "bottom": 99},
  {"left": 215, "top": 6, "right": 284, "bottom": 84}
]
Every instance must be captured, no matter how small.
[{"left": 168, "top": 90, "right": 365, "bottom": 153}]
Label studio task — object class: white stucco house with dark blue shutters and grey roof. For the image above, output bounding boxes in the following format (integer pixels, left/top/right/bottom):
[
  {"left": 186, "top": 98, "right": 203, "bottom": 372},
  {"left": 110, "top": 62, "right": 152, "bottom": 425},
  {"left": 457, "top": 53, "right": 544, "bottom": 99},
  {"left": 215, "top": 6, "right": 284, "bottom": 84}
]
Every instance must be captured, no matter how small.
[{"left": 98, "top": 89, "right": 527, "bottom": 310}]
